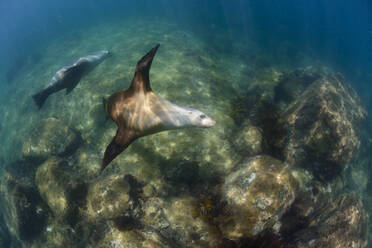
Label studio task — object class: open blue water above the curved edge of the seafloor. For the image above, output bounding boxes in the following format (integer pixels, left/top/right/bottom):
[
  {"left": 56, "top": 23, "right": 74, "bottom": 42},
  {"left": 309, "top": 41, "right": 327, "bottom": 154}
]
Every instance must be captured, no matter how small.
[{"left": 0, "top": 0, "right": 372, "bottom": 92}]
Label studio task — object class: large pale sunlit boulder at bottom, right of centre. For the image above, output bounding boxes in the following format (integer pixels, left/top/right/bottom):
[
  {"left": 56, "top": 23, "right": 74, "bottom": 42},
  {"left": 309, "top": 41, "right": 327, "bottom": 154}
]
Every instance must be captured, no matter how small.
[{"left": 219, "top": 155, "right": 297, "bottom": 241}]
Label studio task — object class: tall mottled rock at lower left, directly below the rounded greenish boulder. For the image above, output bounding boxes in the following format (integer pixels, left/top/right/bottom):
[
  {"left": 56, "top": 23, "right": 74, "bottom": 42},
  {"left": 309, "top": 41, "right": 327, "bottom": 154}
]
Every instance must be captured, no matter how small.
[{"left": 35, "top": 157, "right": 87, "bottom": 219}]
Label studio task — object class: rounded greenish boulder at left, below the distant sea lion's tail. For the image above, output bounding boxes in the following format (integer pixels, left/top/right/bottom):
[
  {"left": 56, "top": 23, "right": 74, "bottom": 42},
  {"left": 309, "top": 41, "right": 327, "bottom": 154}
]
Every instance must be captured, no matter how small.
[{"left": 22, "top": 118, "right": 81, "bottom": 160}]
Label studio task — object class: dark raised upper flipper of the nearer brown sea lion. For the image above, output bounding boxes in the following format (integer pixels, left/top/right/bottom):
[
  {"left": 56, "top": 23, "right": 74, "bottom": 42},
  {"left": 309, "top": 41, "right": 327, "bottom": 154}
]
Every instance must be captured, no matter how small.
[{"left": 129, "top": 44, "right": 160, "bottom": 91}]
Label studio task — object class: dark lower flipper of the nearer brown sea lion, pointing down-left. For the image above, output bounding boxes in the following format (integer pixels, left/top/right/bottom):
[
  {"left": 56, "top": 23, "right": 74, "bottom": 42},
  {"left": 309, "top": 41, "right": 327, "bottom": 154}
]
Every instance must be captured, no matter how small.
[{"left": 101, "top": 128, "right": 136, "bottom": 172}]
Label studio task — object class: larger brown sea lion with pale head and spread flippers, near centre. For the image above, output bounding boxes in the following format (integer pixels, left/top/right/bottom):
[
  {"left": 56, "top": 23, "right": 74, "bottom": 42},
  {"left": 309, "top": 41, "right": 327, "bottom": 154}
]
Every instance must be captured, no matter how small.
[{"left": 101, "top": 44, "right": 216, "bottom": 171}]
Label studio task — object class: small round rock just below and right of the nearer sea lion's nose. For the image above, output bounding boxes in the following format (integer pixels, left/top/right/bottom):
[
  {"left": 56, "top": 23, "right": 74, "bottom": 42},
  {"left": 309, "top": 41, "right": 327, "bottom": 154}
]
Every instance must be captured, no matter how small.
[{"left": 234, "top": 121, "right": 264, "bottom": 156}]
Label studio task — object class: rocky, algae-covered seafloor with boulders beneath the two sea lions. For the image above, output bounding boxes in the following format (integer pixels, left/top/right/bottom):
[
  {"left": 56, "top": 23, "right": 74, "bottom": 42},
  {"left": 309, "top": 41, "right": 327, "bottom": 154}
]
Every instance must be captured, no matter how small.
[{"left": 0, "top": 17, "right": 369, "bottom": 248}]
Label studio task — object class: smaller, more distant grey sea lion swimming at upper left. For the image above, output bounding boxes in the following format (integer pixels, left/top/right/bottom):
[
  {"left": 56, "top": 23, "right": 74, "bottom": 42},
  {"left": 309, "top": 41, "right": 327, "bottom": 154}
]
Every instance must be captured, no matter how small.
[{"left": 32, "top": 50, "right": 110, "bottom": 109}]
